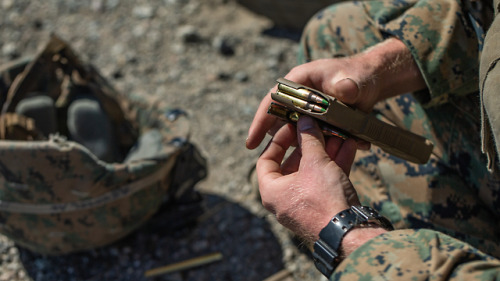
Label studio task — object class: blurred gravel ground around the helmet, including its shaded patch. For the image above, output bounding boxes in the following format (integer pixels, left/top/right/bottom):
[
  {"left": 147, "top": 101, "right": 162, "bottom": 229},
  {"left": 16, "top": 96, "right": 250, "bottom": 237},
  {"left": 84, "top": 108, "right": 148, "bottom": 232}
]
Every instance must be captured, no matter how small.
[{"left": 0, "top": 0, "right": 328, "bottom": 281}]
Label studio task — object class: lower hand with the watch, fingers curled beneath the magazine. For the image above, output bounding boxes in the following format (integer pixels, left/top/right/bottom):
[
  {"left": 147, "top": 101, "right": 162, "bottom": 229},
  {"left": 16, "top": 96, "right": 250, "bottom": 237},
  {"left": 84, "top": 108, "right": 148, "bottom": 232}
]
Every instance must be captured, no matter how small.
[{"left": 257, "top": 116, "right": 359, "bottom": 241}]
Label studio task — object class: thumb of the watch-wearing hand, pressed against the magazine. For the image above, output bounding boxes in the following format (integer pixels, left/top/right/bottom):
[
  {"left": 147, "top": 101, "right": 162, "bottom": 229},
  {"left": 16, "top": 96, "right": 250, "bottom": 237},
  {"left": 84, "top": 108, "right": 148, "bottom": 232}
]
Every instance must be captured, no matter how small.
[{"left": 297, "top": 115, "right": 329, "bottom": 159}]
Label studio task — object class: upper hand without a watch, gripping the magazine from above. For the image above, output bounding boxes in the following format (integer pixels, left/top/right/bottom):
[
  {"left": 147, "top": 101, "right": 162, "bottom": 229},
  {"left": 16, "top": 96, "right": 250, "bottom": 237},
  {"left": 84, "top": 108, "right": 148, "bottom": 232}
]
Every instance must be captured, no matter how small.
[{"left": 246, "top": 38, "right": 425, "bottom": 149}]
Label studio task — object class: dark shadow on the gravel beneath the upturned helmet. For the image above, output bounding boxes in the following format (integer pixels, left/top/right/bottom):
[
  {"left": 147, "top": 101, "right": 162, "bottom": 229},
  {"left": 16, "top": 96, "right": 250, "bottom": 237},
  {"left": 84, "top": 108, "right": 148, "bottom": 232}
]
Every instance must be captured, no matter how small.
[{"left": 19, "top": 194, "right": 283, "bottom": 280}]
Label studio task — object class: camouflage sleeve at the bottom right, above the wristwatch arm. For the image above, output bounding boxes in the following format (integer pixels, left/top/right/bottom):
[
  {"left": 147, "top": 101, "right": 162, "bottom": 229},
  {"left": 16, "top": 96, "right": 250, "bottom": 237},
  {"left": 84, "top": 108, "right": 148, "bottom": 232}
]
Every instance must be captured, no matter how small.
[{"left": 330, "top": 229, "right": 500, "bottom": 281}]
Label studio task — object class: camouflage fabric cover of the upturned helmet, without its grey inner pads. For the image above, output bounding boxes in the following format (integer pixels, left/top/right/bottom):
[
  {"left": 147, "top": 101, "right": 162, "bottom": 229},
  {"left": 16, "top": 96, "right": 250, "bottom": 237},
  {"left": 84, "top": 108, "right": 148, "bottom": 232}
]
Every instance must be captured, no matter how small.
[{"left": 0, "top": 36, "right": 194, "bottom": 254}]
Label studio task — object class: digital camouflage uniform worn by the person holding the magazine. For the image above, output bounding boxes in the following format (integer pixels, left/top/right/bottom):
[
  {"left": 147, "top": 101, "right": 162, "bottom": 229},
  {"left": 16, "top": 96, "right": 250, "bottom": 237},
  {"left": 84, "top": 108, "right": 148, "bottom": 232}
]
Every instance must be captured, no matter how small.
[{"left": 299, "top": 0, "right": 500, "bottom": 280}]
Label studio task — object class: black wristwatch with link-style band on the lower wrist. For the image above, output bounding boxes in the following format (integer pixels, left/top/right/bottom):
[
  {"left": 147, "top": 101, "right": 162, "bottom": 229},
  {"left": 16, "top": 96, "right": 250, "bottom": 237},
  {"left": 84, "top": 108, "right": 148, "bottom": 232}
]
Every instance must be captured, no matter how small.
[{"left": 313, "top": 206, "right": 394, "bottom": 278}]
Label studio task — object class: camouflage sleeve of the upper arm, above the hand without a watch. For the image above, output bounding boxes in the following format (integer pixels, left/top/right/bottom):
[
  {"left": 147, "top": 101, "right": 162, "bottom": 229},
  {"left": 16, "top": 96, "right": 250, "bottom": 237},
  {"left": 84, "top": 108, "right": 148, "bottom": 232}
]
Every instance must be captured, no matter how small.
[{"left": 363, "top": 0, "right": 493, "bottom": 105}]
